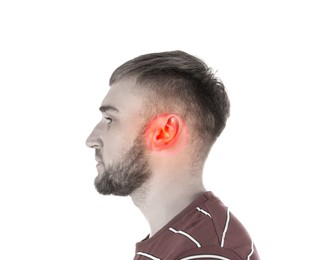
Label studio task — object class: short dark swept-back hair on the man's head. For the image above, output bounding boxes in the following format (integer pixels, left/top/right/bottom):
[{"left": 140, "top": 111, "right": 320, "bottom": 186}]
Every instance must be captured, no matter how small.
[{"left": 109, "top": 51, "right": 230, "bottom": 154}]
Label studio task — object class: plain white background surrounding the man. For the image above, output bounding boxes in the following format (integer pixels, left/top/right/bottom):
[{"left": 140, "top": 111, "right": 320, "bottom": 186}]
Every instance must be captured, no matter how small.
[{"left": 0, "top": 0, "right": 333, "bottom": 260}]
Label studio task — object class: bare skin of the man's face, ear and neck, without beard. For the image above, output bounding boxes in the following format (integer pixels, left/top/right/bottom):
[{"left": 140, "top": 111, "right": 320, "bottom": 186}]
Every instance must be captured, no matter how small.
[{"left": 86, "top": 78, "right": 206, "bottom": 237}]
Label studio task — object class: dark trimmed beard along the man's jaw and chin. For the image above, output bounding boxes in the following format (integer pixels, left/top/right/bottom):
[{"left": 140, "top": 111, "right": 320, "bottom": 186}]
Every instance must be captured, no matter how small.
[{"left": 95, "top": 135, "right": 151, "bottom": 196}]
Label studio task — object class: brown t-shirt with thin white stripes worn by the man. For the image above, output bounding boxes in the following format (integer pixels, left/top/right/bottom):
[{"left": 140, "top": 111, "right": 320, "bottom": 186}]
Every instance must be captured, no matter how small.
[{"left": 134, "top": 191, "right": 259, "bottom": 260}]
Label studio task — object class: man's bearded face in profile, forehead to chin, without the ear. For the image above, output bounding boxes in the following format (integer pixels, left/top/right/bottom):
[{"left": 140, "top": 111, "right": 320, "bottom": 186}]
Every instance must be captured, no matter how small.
[{"left": 86, "top": 79, "right": 150, "bottom": 196}]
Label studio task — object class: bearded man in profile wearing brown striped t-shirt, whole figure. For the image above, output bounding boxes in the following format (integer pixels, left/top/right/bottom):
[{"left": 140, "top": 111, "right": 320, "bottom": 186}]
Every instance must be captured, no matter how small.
[{"left": 87, "top": 51, "right": 259, "bottom": 260}]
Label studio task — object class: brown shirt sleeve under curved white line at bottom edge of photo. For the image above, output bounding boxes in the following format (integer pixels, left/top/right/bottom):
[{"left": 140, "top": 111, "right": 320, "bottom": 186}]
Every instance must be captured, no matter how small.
[{"left": 176, "top": 246, "right": 243, "bottom": 260}]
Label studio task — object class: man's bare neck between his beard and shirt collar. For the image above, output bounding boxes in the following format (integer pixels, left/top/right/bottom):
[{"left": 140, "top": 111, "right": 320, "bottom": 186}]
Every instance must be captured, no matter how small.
[{"left": 131, "top": 173, "right": 205, "bottom": 237}]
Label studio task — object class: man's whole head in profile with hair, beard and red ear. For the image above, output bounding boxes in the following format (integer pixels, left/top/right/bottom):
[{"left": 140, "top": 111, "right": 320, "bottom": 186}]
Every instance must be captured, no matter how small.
[{"left": 87, "top": 51, "right": 229, "bottom": 195}]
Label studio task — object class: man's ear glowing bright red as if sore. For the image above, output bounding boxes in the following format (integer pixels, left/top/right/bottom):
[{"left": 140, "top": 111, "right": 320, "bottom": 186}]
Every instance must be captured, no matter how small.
[{"left": 146, "top": 114, "right": 184, "bottom": 151}]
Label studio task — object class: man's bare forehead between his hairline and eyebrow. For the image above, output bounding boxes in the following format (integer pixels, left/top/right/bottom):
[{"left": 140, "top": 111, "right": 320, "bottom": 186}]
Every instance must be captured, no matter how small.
[{"left": 102, "top": 78, "right": 144, "bottom": 114}]
